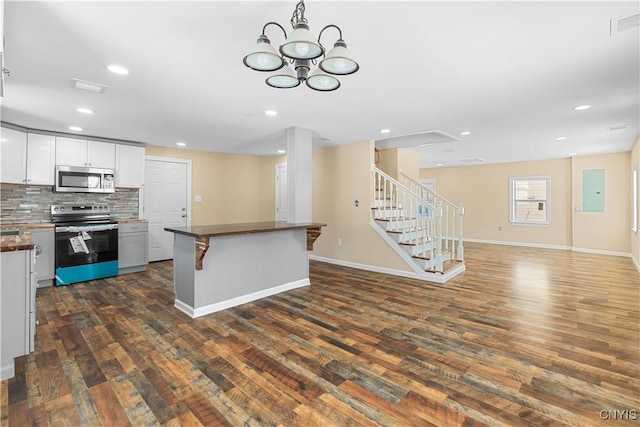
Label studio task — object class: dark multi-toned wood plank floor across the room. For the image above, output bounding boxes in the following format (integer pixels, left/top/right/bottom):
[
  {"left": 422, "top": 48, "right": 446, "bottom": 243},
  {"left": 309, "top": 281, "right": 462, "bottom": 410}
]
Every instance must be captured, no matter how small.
[{"left": 0, "top": 244, "right": 640, "bottom": 427}]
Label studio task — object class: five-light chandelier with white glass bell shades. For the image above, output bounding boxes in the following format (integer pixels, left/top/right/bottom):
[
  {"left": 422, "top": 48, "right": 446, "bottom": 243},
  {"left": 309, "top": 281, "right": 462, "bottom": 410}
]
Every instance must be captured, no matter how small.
[{"left": 242, "top": 0, "right": 360, "bottom": 92}]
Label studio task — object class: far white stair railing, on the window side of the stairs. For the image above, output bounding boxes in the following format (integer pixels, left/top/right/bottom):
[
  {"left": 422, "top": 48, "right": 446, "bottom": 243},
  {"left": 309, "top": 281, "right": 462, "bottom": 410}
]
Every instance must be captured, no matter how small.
[{"left": 399, "top": 172, "right": 464, "bottom": 261}]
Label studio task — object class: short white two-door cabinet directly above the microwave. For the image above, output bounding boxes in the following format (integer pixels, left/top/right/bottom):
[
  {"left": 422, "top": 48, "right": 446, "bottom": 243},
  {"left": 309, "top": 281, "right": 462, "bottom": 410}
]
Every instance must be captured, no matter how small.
[{"left": 56, "top": 138, "right": 116, "bottom": 169}]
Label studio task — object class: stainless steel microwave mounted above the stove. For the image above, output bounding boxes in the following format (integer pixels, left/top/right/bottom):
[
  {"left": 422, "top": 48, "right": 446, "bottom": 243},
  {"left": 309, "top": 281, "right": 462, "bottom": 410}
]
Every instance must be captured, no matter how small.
[{"left": 55, "top": 166, "right": 116, "bottom": 193}]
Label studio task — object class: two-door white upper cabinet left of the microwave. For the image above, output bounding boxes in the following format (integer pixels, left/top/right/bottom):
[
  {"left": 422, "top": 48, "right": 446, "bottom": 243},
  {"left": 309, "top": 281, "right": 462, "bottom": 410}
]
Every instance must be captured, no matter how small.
[{"left": 0, "top": 128, "right": 56, "bottom": 185}]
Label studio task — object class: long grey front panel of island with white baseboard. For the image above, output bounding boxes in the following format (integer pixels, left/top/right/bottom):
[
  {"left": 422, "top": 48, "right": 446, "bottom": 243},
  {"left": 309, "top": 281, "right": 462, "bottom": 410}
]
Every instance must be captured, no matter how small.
[{"left": 195, "top": 228, "right": 309, "bottom": 317}]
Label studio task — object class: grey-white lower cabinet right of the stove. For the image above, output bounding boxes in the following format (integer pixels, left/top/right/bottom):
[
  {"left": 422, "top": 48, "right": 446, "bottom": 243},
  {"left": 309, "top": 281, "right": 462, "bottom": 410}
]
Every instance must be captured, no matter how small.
[{"left": 118, "top": 222, "right": 149, "bottom": 274}]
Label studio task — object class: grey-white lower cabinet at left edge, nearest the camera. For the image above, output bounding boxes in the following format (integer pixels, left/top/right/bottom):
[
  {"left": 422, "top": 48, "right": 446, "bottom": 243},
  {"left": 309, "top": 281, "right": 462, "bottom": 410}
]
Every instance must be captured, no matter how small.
[{"left": 0, "top": 250, "right": 36, "bottom": 380}]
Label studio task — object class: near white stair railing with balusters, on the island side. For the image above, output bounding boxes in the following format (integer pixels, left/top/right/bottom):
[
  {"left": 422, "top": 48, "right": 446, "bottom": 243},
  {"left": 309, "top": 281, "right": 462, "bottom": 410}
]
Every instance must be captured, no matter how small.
[{"left": 371, "top": 166, "right": 444, "bottom": 272}]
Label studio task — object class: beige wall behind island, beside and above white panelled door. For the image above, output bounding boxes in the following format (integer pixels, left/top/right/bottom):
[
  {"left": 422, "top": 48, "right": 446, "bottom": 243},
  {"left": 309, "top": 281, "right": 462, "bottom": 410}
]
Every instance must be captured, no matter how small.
[{"left": 145, "top": 146, "right": 264, "bottom": 225}]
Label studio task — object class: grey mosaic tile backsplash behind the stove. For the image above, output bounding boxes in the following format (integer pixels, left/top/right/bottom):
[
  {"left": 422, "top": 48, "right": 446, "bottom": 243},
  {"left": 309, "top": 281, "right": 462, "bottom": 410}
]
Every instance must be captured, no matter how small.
[{"left": 0, "top": 184, "right": 140, "bottom": 224}]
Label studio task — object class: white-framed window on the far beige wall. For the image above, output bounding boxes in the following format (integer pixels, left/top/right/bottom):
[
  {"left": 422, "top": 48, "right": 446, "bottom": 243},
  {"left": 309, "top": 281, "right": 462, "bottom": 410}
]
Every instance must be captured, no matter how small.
[{"left": 509, "top": 176, "right": 551, "bottom": 225}]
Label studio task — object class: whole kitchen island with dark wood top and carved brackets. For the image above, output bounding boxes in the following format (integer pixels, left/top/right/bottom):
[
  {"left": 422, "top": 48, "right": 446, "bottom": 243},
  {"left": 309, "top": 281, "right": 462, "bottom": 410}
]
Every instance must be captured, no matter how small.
[{"left": 165, "top": 221, "right": 326, "bottom": 318}]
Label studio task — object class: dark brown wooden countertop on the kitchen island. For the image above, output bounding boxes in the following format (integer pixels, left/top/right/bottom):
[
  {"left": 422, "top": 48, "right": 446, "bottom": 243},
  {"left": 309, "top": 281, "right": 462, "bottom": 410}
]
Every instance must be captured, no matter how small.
[{"left": 165, "top": 221, "right": 327, "bottom": 238}]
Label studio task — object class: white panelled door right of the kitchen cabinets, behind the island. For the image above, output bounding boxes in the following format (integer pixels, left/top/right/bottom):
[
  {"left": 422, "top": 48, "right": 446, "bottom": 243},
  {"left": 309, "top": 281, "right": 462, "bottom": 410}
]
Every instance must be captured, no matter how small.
[{"left": 144, "top": 159, "right": 189, "bottom": 261}]
